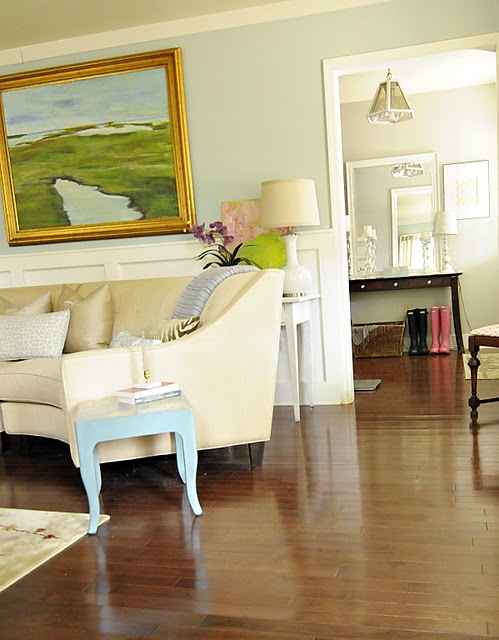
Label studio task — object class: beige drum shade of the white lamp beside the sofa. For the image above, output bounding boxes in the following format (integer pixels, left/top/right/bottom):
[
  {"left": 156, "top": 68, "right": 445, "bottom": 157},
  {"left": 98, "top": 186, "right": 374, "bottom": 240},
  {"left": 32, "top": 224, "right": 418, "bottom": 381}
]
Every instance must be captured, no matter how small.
[{"left": 260, "top": 178, "right": 320, "bottom": 227}]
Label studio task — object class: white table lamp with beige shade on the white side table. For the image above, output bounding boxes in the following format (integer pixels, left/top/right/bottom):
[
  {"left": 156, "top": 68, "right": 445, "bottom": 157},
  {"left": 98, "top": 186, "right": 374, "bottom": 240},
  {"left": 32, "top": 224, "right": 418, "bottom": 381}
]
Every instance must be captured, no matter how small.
[{"left": 259, "top": 178, "right": 320, "bottom": 297}]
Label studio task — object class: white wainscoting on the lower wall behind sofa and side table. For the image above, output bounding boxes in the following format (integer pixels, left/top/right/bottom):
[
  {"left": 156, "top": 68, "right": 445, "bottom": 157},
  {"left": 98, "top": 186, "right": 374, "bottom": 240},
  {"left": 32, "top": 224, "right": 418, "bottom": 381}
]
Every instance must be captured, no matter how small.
[{"left": 0, "top": 229, "right": 351, "bottom": 411}]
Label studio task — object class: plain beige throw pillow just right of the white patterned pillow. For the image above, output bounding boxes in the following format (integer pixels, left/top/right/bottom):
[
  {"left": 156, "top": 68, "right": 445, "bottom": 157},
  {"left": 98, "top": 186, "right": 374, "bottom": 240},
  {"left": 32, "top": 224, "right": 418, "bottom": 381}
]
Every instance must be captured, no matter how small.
[{"left": 56, "top": 284, "right": 113, "bottom": 353}]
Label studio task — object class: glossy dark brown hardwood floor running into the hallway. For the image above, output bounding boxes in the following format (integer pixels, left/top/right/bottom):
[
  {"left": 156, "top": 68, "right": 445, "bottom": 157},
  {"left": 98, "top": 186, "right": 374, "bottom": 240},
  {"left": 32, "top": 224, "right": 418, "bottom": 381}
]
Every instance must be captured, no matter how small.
[{"left": 0, "top": 353, "right": 499, "bottom": 640}]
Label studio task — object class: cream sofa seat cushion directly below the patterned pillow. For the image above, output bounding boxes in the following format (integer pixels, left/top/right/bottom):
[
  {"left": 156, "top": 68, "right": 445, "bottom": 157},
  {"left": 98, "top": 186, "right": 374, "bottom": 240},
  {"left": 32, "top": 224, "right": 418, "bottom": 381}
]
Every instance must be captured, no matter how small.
[{"left": 0, "top": 358, "right": 61, "bottom": 407}]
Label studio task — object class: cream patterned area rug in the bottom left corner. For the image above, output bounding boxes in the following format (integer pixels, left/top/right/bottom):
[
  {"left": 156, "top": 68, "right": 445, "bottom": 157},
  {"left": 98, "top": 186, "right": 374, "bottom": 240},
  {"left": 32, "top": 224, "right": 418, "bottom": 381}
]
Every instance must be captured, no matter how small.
[{"left": 0, "top": 508, "right": 109, "bottom": 591}]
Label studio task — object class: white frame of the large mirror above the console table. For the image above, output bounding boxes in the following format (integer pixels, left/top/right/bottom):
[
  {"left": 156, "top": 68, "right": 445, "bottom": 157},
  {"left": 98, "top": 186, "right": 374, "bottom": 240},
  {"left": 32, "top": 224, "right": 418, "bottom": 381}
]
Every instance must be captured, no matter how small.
[{"left": 345, "top": 151, "right": 440, "bottom": 279}]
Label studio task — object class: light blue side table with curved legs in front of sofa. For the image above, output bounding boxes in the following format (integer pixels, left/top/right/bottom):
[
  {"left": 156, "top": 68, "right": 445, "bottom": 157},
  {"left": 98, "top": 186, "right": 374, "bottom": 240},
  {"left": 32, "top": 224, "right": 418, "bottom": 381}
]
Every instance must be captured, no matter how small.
[{"left": 75, "top": 394, "right": 203, "bottom": 534}]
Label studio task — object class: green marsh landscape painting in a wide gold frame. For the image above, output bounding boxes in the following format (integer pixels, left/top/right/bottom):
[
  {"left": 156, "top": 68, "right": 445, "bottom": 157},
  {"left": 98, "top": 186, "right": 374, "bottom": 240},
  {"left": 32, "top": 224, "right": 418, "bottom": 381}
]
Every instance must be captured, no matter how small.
[{"left": 0, "top": 48, "right": 196, "bottom": 245}]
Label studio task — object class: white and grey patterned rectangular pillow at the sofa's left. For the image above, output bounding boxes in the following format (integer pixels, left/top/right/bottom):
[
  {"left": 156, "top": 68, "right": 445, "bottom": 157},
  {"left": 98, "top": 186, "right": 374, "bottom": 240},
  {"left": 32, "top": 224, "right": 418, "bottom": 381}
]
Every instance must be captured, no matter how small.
[{"left": 0, "top": 309, "right": 69, "bottom": 360}]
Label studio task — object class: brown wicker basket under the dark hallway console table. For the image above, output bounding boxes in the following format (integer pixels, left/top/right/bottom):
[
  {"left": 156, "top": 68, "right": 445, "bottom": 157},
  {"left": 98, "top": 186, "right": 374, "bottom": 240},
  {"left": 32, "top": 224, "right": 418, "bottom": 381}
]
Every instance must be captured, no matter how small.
[{"left": 352, "top": 321, "right": 405, "bottom": 358}]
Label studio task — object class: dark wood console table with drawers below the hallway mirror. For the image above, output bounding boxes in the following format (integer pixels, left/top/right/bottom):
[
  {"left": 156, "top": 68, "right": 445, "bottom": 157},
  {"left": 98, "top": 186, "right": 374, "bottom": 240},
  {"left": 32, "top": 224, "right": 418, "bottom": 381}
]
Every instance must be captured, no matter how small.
[{"left": 350, "top": 273, "right": 464, "bottom": 353}]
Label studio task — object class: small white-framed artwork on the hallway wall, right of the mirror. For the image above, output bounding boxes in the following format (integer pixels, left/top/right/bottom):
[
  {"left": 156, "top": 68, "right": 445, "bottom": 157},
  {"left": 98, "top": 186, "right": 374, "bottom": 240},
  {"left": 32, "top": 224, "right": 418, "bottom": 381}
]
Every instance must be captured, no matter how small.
[{"left": 444, "top": 160, "right": 490, "bottom": 220}]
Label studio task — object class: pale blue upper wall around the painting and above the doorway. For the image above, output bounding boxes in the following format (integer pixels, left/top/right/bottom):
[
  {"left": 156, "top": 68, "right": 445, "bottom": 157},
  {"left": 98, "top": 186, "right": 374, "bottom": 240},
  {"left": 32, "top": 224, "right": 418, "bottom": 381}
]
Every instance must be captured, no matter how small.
[{"left": 0, "top": 0, "right": 499, "bottom": 254}]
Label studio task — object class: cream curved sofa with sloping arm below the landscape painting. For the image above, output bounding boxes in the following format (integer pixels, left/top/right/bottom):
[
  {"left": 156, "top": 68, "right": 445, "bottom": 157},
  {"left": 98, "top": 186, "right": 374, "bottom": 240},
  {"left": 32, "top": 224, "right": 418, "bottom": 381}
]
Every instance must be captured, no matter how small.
[{"left": 0, "top": 269, "right": 283, "bottom": 466}]
